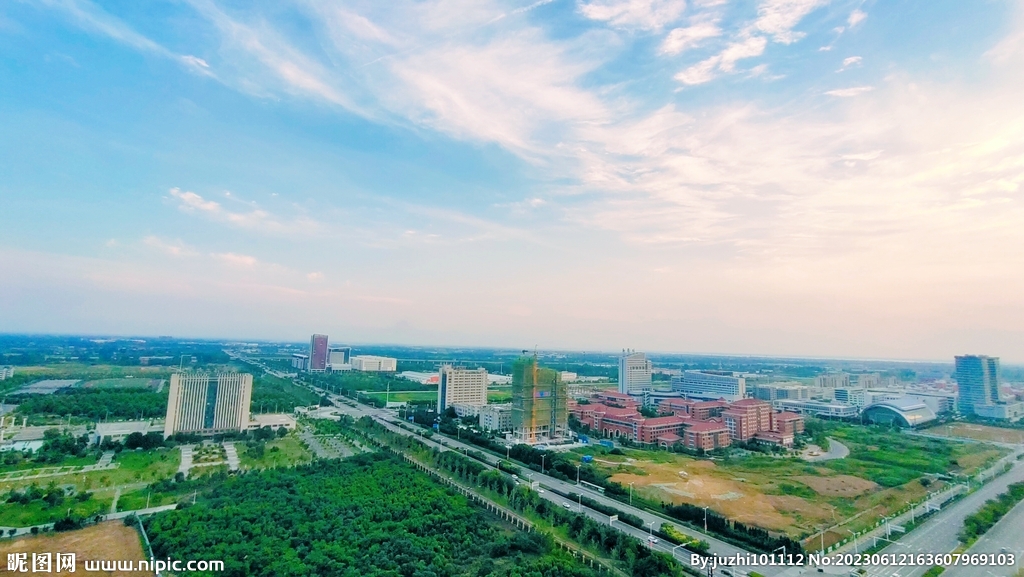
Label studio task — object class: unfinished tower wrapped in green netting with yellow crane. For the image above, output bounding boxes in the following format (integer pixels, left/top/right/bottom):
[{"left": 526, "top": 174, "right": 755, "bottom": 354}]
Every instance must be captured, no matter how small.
[{"left": 512, "top": 357, "right": 569, "bottom": 445}]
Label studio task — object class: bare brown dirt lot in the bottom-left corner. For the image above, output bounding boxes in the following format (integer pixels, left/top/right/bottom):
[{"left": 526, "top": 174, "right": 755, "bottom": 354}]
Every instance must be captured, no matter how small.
[{"left": 0, "top": 521, "right": 153, "bottom": 577}]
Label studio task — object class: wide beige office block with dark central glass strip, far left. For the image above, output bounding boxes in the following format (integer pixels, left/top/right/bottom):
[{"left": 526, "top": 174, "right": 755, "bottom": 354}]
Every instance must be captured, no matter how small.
[{"left": 164, "top": 373, "right": 253, "bottom": 437}]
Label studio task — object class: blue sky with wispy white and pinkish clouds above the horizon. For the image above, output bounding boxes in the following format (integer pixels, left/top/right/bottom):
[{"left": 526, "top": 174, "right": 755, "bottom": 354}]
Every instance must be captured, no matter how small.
[{"left": 0, "top": 0, "right": 1024, "bottom": 361}]
